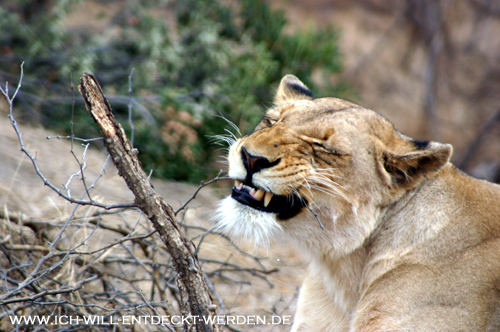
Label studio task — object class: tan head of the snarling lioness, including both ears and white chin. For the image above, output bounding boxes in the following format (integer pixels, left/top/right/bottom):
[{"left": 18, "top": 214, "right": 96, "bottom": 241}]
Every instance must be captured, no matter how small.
[{"left": 219, "top": 75, "right": 451, "bottom": 252}]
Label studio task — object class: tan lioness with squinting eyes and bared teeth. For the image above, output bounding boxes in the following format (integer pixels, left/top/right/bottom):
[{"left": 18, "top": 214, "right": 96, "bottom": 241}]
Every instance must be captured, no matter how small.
[{"left": 218, "top": 75, "right": 500, "bottom": 332}]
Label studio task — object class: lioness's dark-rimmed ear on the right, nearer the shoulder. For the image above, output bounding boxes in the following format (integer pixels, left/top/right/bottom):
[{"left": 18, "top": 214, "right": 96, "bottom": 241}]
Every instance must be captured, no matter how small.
[{"left": 379, "top": 141, "right": 453, "bottom": 188}]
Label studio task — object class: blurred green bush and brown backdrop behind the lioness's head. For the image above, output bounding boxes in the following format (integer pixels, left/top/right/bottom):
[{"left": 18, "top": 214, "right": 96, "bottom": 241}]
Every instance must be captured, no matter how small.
[{"left": 0, "top": 0, "right": 500, "bottom": 182}]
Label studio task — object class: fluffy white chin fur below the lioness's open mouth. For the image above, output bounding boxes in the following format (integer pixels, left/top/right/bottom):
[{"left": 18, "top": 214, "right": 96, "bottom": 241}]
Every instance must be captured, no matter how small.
[{"left": 216, "top": 196, "right": 282, "bottom": 247}]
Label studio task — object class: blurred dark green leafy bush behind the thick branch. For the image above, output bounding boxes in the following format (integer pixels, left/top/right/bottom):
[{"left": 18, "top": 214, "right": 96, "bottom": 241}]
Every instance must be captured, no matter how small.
[{"left": 0, "top": 0, "right": 348, "bottom": 181}]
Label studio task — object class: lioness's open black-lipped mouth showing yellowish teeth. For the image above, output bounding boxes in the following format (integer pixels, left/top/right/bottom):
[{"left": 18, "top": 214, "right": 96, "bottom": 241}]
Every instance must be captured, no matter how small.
[{"left": 231, "top": 180, "right": 307, "bottom": 220}]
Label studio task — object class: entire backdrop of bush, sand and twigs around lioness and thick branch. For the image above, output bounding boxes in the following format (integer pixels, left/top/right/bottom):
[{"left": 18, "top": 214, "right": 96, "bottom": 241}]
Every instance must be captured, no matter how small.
[{"left": 0, "top": 0, "right": 500, "bottom": 332}]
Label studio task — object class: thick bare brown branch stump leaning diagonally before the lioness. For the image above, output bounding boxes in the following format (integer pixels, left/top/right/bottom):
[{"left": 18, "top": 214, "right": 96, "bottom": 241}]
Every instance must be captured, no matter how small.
[{"left": 79, "top": 73, "right": 218, "bottom": 331}]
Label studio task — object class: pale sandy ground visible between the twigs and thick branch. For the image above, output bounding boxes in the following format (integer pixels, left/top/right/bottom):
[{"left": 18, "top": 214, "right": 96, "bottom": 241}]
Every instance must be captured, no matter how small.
[{"left": 0, "top": 114, "right": 304, "bottom": 331}]
